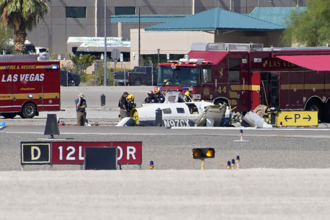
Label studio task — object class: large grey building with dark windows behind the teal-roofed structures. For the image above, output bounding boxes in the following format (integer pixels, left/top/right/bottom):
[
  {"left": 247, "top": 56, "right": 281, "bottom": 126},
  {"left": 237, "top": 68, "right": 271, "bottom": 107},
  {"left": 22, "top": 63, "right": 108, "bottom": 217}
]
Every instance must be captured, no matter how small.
[{"left": 27, "top": 0, "right": 307, "bottom": 59}]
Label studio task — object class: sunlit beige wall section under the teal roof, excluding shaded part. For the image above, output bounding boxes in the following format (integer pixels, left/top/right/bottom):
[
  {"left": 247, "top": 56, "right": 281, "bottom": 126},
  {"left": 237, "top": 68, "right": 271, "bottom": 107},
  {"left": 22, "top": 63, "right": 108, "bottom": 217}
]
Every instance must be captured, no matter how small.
[{"left": 130, "top": 29, "right": 214, "bottom": 68}]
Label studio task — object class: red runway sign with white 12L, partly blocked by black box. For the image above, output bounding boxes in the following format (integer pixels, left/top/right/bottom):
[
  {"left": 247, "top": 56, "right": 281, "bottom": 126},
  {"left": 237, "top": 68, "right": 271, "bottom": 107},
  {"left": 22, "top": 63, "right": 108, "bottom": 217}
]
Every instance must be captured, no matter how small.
[{"left": 51, "top": 142, "right": 142, "bottom": 165}]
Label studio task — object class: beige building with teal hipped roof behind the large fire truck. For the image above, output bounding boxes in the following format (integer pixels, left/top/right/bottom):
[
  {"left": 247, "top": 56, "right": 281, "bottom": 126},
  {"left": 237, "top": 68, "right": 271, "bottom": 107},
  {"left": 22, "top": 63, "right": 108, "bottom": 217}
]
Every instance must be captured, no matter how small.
[{"left": 130, "top": 8, "right": 285, "bottom": 68}]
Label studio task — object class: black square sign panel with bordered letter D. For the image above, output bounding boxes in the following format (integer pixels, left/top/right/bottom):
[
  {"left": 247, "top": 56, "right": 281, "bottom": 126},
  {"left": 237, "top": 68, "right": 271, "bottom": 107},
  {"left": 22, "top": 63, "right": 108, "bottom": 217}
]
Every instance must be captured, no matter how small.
[{"left": 21, "top": 142, "right": 51, "bottom": 165}]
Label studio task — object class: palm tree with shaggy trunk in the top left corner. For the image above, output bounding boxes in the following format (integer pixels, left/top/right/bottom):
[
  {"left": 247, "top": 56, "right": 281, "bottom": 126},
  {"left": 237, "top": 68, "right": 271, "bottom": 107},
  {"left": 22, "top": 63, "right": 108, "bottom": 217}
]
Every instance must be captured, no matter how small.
[{"left": 0, "top": 0, "right": 49, "bottom": 54}]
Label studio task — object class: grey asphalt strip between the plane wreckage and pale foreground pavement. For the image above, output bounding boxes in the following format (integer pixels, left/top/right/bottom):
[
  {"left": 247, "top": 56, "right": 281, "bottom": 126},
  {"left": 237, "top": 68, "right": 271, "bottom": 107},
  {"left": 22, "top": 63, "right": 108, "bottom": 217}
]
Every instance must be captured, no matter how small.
[{"left": 0, "top": 125, "right": 330, "bottom": 171}]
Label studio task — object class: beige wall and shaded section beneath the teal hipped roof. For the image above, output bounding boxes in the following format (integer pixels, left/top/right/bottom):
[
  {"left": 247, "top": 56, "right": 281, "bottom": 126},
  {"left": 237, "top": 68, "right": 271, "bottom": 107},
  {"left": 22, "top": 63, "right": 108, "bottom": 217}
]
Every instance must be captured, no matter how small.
[{"left": 130, "top": 29, "right": 282, "bottom": 69}]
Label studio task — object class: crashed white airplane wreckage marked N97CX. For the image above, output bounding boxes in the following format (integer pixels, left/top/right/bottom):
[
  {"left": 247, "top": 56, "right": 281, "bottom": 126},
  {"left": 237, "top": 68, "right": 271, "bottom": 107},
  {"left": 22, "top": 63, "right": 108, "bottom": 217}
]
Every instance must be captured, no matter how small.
[{"left": 117, "top": 91, "right": 272, "bottom": 128}]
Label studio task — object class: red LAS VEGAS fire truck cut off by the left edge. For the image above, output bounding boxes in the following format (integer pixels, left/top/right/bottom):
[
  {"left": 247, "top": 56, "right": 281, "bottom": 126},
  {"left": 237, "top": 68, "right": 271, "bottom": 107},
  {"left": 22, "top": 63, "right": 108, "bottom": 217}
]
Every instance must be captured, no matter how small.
[{"left": 0, "top": 55, "right": 61, "bottom": 118}]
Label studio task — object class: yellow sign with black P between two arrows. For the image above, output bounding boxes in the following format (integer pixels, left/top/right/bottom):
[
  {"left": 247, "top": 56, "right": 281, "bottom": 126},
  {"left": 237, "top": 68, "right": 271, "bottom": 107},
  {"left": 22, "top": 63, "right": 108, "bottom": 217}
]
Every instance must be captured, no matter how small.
[{"left": 277, "top": 111, "right": 319, "bottom": 126}]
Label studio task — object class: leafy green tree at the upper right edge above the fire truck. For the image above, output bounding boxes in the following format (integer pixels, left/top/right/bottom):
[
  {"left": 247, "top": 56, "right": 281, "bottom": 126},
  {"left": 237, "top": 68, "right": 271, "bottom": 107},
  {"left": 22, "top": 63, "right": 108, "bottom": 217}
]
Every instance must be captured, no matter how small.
[{"left": 282, "top": 0, "right": 330, "bottom": 47}]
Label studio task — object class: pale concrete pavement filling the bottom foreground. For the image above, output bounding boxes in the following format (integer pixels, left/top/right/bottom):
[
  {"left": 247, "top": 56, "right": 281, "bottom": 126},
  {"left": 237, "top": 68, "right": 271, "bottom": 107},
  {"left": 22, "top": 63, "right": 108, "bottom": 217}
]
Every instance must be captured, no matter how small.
[{"left": 0, "top": 169, "right": 330, "bottom": 220}]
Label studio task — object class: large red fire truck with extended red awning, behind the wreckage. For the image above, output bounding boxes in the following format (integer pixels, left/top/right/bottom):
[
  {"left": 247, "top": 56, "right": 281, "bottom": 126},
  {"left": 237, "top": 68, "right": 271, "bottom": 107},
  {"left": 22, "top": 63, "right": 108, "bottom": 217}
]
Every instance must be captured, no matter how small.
[{"left": 157, "top": 43, "right": 330, "bottom": 122}]
